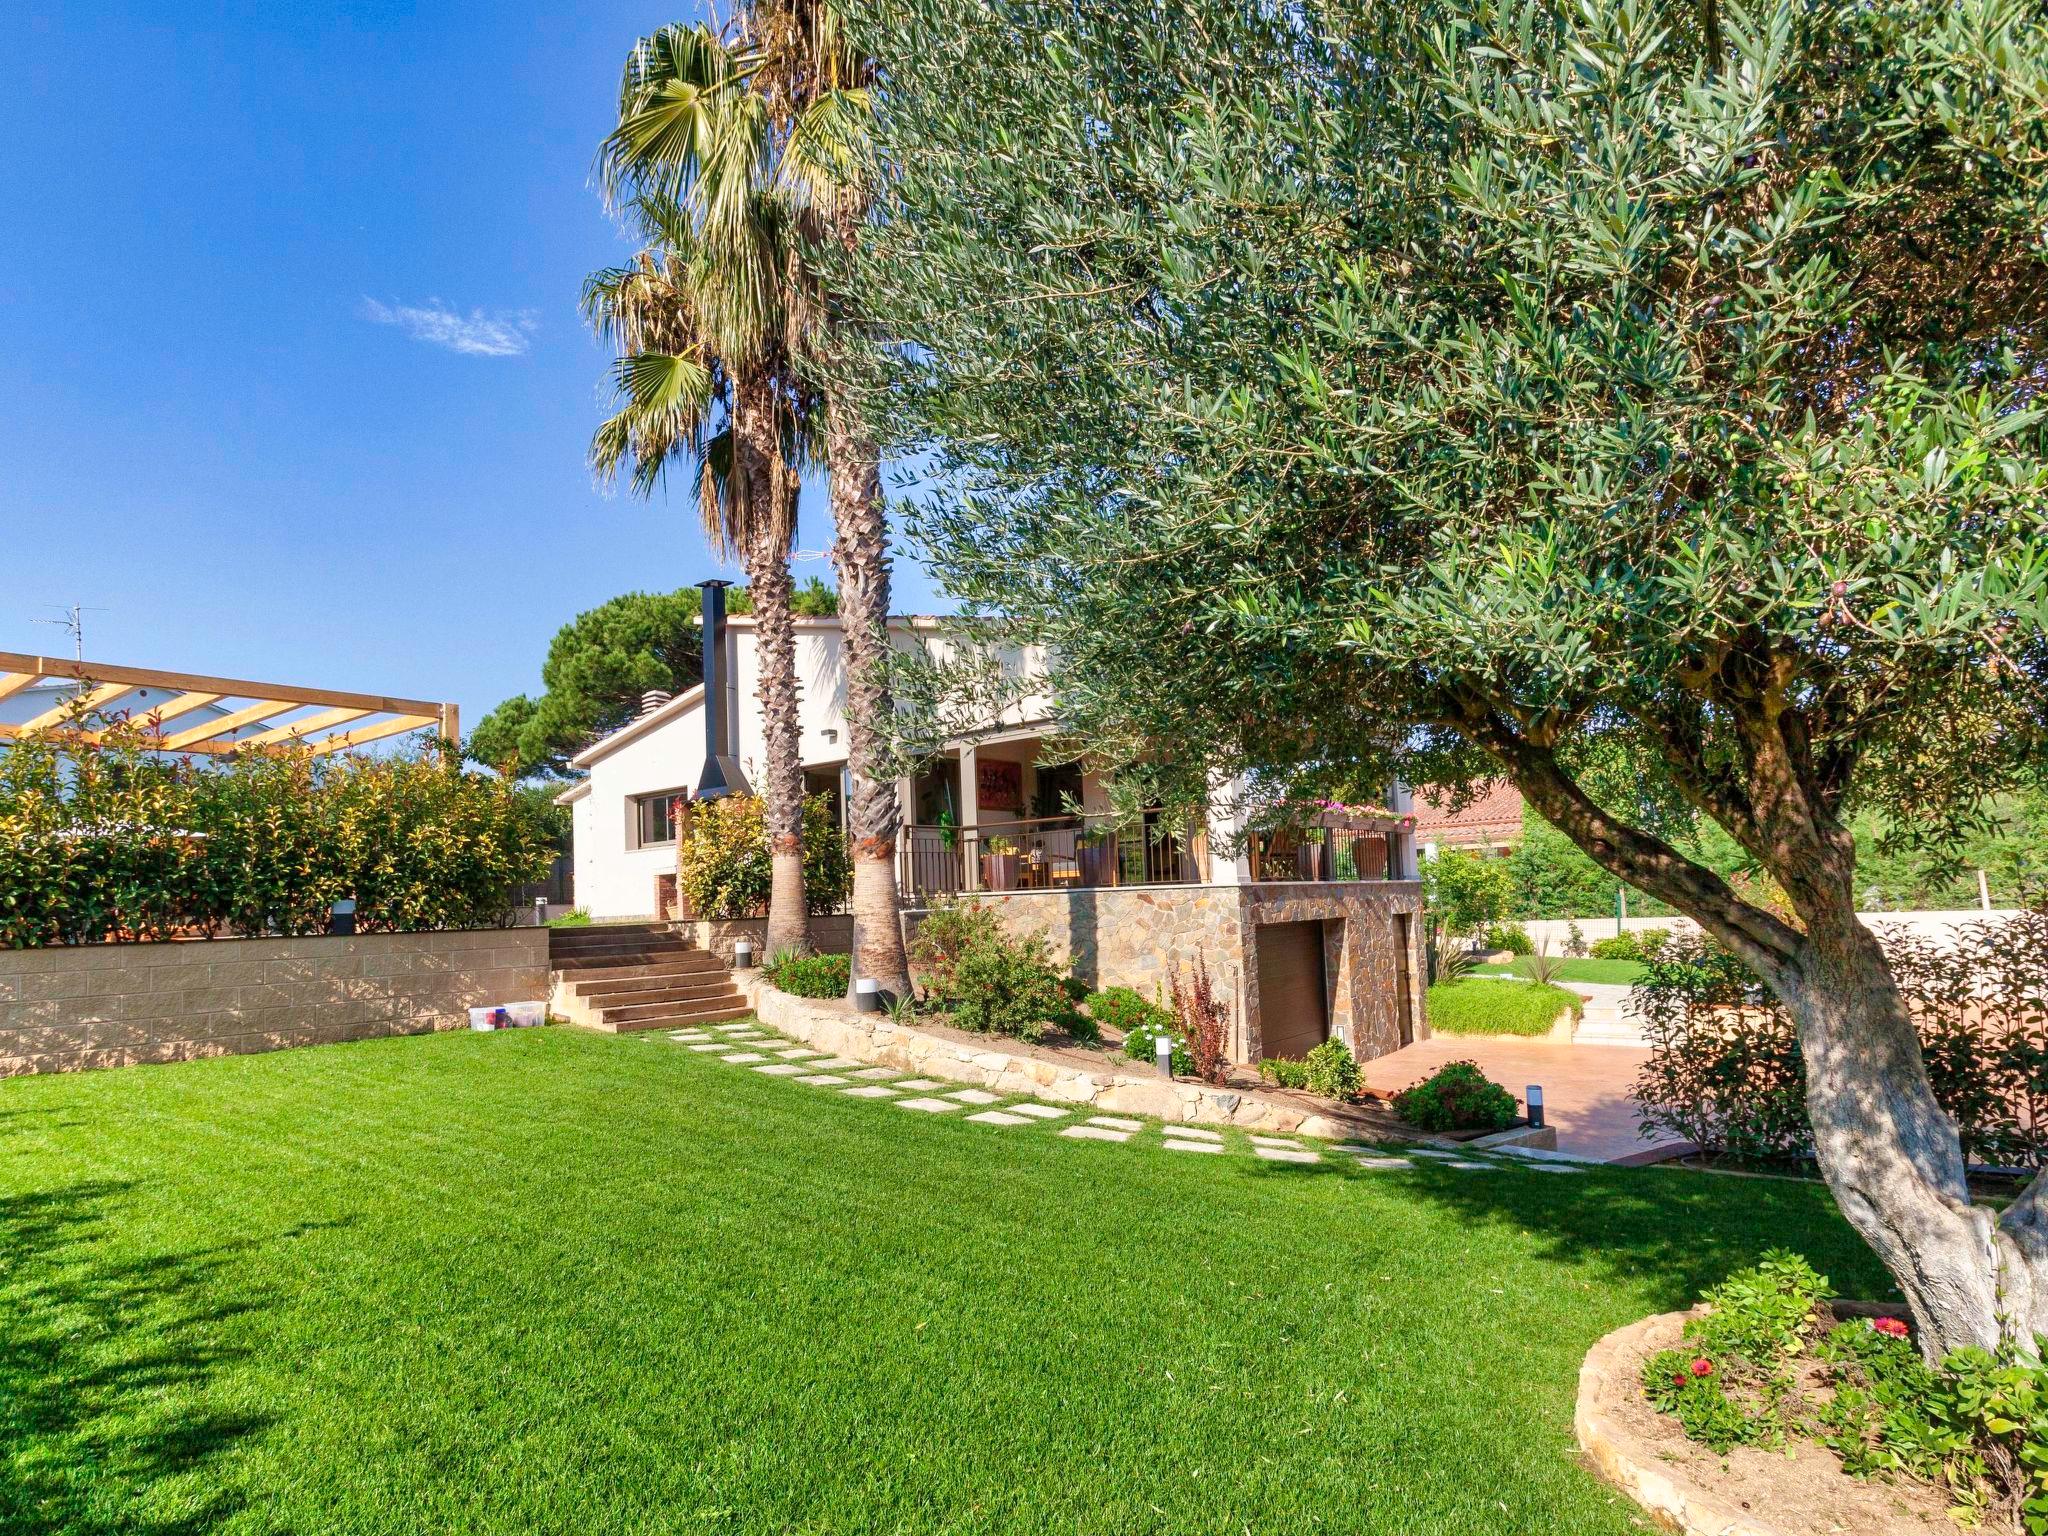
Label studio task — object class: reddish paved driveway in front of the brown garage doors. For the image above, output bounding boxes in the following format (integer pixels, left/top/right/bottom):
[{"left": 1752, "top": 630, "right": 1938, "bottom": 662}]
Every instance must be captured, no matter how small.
[{"left": 1360, "top": 1034, "right": 1673, "bottom": 1163}]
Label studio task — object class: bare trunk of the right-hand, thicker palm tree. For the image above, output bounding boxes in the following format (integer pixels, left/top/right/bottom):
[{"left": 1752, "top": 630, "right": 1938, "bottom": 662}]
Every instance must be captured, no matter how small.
[{"left": 825, "top": 397, "right": 909, "bottom": 997}]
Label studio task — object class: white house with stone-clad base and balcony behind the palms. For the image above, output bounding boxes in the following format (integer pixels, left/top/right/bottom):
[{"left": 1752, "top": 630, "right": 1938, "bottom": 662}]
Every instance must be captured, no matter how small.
[{"left": 557, "top": 592, "right": 1427, "bottom": 1061}]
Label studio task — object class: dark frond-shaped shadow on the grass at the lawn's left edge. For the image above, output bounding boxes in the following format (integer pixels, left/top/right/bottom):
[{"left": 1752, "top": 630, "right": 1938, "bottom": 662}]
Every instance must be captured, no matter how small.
[{"left": 0, "top": 1180, "right": 354, "bottom": 1536}]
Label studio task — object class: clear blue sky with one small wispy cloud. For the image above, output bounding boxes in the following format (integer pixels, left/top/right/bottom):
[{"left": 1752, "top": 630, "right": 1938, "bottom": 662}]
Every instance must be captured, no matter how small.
[{"left": 0, "top": 0, "right": 946, "bottom": 723}]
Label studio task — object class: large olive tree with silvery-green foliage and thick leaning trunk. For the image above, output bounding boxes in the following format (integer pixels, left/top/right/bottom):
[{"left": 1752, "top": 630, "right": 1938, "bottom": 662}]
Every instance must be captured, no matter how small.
[{"left": 858, "top": 0, "right": 2048, "bottom": 1352}]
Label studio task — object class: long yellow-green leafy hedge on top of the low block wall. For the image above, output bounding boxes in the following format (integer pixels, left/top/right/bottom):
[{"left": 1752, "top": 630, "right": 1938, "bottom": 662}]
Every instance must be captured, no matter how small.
[{"left": 0, "top": 721, "right": 555, "bottom": 948}]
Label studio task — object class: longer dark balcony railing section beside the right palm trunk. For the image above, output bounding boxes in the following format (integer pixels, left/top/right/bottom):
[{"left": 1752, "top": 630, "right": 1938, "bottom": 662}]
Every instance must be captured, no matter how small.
[{"left": 897, "top": 815, "right": 1208, "bottom": 905}]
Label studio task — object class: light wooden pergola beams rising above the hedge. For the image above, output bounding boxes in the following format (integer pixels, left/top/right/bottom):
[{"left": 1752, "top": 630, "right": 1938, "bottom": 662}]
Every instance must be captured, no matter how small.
[{"left": 0, "top": 651, "right": 461, "bottom": 756}]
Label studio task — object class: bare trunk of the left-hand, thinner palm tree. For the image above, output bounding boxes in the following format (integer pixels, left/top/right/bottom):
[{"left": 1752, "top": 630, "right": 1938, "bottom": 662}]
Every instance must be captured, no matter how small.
[{"left": 733, "top": 387, "right": 811, "bottom": 954}]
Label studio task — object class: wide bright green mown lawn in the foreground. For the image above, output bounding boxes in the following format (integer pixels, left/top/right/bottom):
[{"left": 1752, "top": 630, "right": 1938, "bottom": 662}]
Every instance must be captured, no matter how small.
[{"left": 0, "top": 1028, "right": 1880, "bottom": 1536}]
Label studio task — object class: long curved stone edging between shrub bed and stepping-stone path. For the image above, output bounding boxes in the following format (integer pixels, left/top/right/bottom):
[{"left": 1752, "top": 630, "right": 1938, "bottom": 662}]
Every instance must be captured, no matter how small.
[{"left": 735, "top": 971, "right": 1352, "bottom": 1141}]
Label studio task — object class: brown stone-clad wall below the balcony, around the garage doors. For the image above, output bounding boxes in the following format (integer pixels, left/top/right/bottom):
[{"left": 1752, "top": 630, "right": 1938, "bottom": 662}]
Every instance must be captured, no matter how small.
[{"left": 905, "top": 881, "right": 1430, "bottom": 1061}]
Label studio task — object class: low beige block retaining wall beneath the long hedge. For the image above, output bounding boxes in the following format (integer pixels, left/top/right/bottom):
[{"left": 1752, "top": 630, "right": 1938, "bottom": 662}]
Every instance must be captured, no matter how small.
[{"left": 0, "top": 928, "right": 549, "bottom": 1077}]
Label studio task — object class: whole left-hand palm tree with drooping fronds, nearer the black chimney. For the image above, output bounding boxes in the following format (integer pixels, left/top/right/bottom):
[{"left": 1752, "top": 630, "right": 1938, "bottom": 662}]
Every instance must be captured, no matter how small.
[{"left": 584, "top": 78, "right": 809, "bottom": 954}]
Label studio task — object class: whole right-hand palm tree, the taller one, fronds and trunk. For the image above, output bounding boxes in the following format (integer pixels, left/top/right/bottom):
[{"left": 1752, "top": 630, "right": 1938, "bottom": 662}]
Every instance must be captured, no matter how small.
[{"left": 608, "top": 0, "right": 909, "bottom": 995}]
